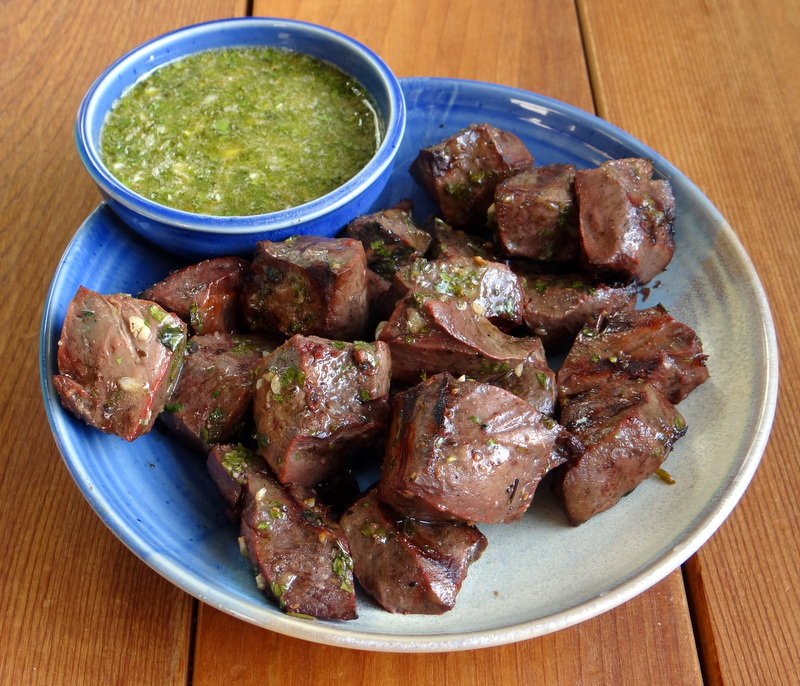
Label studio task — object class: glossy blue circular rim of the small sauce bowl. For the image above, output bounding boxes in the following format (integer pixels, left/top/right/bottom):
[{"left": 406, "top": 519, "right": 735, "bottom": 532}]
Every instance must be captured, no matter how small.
[{"left": 75, "top": 17, "right": 406, "bottom": 235}]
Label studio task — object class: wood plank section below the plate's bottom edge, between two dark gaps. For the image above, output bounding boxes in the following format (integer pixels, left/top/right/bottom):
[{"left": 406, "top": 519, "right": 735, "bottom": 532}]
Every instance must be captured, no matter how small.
[{"left": 193, "top": 571, "right": 702, "bottom": 686}]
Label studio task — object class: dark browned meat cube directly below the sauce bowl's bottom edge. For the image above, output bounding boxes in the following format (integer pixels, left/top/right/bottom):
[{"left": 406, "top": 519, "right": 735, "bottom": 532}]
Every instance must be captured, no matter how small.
[{"left": 244, "top": 236, "right": 368, "bottom": 340}]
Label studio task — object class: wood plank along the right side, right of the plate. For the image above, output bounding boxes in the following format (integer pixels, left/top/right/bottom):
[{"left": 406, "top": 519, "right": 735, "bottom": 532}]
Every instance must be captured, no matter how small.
[{"left": 579, "top": 0, "right": 800, "bottom": 684}]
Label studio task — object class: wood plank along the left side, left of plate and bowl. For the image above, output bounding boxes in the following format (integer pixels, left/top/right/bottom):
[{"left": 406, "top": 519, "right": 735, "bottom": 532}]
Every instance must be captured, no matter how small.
[{"left": 0, "top": 0, "right": 244, "bottom": 684}]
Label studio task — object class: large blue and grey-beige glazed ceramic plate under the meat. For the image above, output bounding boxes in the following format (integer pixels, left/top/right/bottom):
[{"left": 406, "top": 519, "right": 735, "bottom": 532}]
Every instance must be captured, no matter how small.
[{"left": 41, "top": 78, "right": 778, "bottom": 652}]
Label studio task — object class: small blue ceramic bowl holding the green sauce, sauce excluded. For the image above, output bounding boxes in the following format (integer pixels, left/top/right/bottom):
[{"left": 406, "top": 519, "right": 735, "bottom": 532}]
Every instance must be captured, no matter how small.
[{"left": 75, "top": 17, "right": 406, "bottom": 259}]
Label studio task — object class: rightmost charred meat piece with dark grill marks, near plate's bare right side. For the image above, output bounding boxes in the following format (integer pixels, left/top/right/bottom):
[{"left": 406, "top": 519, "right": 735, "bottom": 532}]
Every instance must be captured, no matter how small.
[{"left": 556, "top": 305, "right": 708, "bottom": 404}]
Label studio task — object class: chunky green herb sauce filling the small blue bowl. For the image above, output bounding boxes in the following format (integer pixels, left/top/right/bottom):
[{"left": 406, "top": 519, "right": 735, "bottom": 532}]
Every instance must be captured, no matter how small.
[{"left": 101, "top": 48, "right": 382, "bottom": 215}]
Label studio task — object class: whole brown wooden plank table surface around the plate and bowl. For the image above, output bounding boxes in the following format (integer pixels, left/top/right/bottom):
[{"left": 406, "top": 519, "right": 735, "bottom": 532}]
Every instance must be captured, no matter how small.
[{"left": 0, "top": 0, "right": 800, "bottom": 686}]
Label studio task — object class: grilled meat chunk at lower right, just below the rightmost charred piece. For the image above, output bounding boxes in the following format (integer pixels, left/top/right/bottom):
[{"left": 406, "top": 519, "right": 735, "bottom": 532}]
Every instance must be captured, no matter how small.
[{"left": 555, "top": 379, "right": 686, "bottom": 525}]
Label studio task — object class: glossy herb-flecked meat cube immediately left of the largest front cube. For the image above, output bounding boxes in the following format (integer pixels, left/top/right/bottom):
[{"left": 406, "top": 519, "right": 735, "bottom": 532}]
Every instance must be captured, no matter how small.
[{"left": 253, "top": 335, "right": 391, "bottom": 486}]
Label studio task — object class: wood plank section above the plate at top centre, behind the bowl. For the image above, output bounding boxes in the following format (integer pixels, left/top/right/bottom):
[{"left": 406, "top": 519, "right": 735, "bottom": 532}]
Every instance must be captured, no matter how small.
[{"left": 253, "top": 0, "right": 593, "bottom": 110}]
